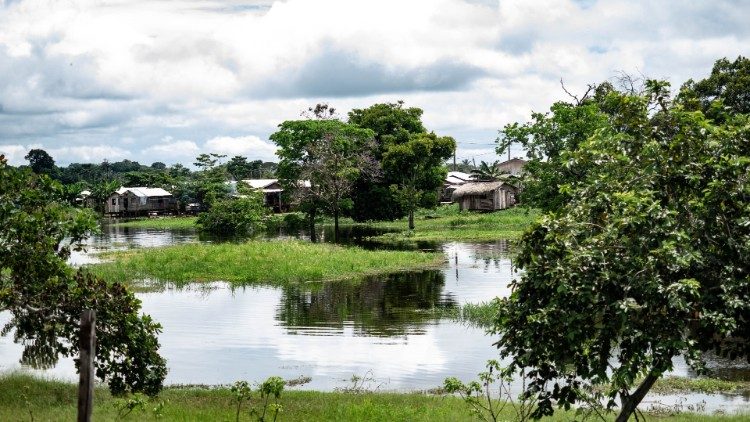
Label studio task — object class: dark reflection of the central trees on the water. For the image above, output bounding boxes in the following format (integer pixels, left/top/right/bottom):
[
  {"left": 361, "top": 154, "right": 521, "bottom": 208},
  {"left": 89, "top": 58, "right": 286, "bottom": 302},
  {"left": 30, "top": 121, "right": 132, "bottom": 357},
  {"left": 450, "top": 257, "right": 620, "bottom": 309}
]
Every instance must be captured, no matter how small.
[{"left": 276, "top": 271, "right": 457, "bottom": 337}]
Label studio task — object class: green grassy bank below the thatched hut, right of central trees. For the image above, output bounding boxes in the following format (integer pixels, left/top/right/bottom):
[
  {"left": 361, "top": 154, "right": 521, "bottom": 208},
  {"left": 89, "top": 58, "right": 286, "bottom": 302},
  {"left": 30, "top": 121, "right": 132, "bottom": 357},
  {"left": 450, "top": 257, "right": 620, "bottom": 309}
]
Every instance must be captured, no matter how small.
[{"left": 372, "top": 204, "right": 540, "bottom": 242}]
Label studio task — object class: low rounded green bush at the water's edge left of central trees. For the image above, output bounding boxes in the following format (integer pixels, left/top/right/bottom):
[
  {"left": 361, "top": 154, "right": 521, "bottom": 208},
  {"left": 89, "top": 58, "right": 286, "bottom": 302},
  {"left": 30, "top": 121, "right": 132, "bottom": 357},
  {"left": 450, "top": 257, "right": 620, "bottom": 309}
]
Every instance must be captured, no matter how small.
[{"left": 196, "top": 192, "right": 268, "bottom": 236}]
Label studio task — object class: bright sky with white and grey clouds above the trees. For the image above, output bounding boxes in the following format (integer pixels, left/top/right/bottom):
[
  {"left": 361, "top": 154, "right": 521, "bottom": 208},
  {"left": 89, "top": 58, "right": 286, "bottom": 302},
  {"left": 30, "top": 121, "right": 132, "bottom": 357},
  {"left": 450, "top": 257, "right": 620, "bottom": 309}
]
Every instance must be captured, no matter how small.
[{"left": 0, "top": 0, "right": 750, "bottom": 165}]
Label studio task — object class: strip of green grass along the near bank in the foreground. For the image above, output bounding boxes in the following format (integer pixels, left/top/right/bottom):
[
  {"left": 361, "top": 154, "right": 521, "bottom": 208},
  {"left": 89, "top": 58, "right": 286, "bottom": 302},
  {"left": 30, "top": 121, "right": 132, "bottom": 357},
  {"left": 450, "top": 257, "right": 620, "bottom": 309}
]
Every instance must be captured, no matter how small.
[{"left": 0, "top": 373, "right": 748, "bottom": 422}]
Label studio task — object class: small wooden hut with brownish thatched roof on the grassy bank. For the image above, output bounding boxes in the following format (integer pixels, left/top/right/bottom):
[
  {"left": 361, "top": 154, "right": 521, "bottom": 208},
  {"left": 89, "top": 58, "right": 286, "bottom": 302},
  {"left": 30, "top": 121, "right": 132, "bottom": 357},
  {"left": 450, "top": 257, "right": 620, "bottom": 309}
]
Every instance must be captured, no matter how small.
[{"left": 452, "top": 181, "right": 518, "bottom": 211}]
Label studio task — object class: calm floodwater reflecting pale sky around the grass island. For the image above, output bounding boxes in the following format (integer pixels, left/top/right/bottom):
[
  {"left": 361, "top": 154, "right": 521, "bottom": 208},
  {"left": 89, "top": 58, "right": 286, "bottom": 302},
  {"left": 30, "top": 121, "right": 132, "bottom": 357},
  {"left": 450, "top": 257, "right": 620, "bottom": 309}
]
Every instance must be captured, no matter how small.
[{"left": 0, "top": 226, "right": 750, "bottom": 411}]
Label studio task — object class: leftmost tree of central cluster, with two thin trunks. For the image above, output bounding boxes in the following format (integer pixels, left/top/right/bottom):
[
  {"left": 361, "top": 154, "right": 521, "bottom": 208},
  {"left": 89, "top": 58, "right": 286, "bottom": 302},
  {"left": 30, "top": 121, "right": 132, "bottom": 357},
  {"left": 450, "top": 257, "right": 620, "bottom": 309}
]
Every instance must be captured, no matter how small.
[{"left": 270, "top": 119, "right": 377, "bottom": 239}]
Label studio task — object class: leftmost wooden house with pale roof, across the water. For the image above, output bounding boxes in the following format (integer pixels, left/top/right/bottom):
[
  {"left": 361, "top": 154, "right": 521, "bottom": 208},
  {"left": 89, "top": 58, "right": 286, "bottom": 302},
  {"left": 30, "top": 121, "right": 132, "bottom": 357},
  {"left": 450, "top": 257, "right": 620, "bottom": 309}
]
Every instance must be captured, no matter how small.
[{"left": 104, "top": 187, "right": 177, "bottom": 216}]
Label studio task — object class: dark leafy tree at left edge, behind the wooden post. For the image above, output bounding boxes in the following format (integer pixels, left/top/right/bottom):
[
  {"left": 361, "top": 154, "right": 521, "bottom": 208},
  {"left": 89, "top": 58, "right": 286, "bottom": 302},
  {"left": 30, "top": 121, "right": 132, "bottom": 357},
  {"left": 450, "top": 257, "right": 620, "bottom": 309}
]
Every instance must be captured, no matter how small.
[{"left": 0, "top": 156, "right": 167, "bottom": 394}]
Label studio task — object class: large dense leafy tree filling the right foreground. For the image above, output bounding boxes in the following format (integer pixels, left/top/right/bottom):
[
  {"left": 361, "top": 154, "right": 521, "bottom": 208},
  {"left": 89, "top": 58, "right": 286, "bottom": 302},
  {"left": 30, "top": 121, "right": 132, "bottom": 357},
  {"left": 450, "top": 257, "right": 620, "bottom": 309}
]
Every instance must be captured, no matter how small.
[{"left": 495, "top": 81, "right": 750, "bottom": 421}]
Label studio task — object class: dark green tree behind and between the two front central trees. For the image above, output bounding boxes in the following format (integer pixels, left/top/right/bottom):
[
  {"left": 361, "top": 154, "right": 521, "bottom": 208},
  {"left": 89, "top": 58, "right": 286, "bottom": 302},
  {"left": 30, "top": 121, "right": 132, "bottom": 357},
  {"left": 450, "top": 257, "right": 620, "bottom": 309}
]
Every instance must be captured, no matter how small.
[{"left": 349, "top": 101, "right": 427, "bottom": 221}]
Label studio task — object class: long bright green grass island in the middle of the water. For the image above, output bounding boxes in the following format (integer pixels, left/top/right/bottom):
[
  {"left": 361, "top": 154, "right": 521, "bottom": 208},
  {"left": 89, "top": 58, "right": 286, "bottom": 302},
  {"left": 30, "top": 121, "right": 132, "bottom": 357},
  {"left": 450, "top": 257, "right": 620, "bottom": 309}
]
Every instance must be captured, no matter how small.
[{"left": 89, "top": 241, "right": 444, "bottom": 285}]
